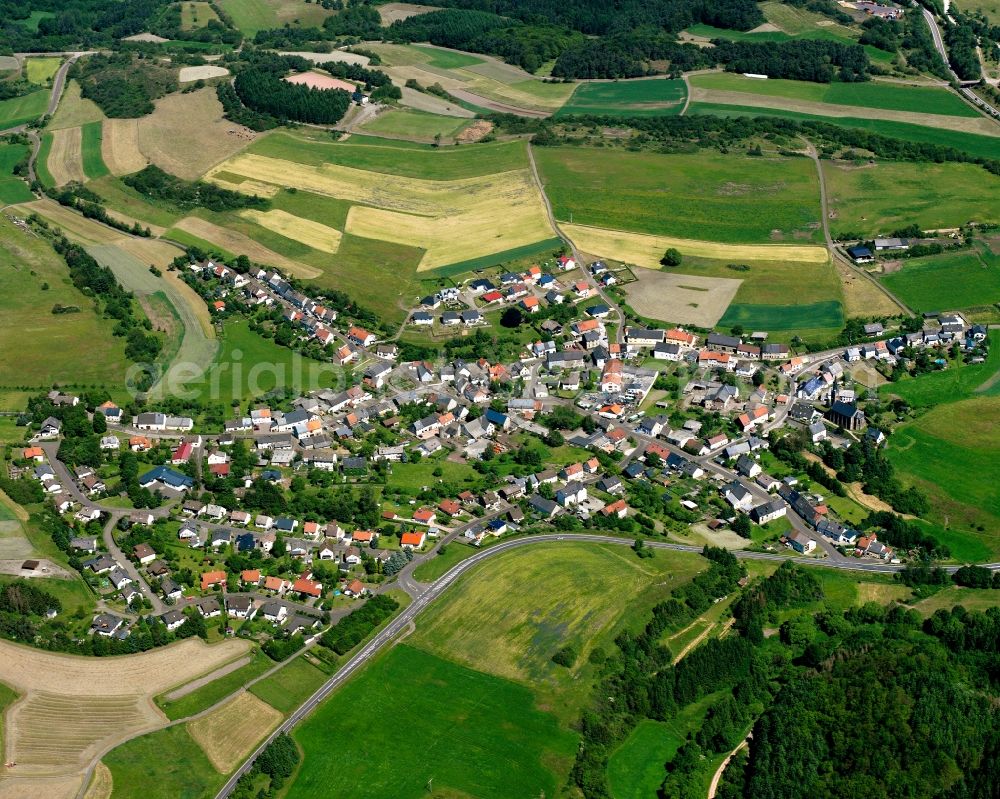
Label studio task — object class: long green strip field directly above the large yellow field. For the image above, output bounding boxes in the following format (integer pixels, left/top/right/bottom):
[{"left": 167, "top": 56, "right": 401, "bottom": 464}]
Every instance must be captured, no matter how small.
[{"left": 247, "top": 133, "right": 528, "bottom": 180}]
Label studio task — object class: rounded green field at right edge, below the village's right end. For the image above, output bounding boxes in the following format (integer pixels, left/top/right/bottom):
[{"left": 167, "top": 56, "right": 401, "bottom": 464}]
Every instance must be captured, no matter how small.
[{"left": 887, "top": 396, "right": 1000, "bottom": 554}]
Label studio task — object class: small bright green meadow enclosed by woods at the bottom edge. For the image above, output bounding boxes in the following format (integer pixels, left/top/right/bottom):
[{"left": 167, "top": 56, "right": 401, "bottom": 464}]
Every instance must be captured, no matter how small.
[{"left": 608, "top": 719, "right": 684, "bottom": 799}]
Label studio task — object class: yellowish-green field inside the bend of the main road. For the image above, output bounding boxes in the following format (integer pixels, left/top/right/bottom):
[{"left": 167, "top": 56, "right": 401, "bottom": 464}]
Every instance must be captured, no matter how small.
[{"left": 408, "top": 544, "right": 704, "bottom": 723}]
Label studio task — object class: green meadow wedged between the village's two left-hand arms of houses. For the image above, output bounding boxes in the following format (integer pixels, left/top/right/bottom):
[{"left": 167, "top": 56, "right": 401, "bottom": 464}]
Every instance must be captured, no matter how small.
[{"left": 188, "top": 320, "right": 342, "bottom": 405}]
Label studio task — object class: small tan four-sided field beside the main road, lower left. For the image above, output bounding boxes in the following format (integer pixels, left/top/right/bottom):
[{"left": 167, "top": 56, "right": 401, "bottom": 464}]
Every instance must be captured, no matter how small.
[{"left": 187, "top": 691, "right": 284, "bottom": 774}]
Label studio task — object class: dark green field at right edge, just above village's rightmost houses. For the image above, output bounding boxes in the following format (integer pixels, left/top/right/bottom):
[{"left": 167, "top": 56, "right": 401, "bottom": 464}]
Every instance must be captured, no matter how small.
[{"left": 880, "top": 247, "right": 1000, "bottom": 312}]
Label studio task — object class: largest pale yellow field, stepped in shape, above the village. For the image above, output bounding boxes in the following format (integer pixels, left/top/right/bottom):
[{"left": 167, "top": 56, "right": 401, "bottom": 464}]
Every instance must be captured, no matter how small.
[{"left": 207, "top": 154, "right": 556, "bottom": 271}]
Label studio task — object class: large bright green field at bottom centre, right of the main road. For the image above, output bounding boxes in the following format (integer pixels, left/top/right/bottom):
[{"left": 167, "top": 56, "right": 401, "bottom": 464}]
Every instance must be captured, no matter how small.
[{"left": 286, "top": 644, "right": 578, "bottom": 799}]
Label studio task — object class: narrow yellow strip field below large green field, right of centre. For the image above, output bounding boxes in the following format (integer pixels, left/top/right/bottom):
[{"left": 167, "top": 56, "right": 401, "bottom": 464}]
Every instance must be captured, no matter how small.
[{"left": 560, "top": 224, "right": 829, "bottom": 269}]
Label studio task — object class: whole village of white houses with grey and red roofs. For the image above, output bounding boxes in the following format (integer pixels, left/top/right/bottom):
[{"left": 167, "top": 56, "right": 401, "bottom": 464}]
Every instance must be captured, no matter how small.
[{"left": 11, "top": 247, "right": 986, "bottom": 638}]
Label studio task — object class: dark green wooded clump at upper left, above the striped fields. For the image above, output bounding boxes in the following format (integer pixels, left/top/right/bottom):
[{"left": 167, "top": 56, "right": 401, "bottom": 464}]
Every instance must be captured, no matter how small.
[{"left": 70, "top": 53, "right": 177, "bottom": 118}]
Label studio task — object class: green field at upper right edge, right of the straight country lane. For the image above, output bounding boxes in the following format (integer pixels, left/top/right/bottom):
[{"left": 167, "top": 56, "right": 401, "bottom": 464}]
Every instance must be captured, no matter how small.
[{"left": 822, "top": 160, "right": 1000, "bottom": 238}]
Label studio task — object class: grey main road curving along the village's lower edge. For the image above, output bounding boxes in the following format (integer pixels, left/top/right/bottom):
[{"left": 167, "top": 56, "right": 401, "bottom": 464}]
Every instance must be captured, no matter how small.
[{"left": 216, "top": 533, "right": 988, "bottom": 799}]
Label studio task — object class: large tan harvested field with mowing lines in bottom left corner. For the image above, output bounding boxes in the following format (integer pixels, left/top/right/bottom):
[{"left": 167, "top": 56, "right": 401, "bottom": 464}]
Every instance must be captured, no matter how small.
[{"left": 0, "top": 639, "right": 247, "bottom": 780}]
